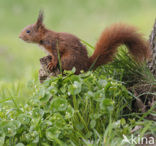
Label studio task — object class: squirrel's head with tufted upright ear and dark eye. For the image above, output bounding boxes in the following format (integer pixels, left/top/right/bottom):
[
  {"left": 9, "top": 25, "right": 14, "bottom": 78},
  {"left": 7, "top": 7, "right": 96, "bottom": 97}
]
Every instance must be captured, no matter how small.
[{"left": 19, "top": 11, "right": 45, "bottom": 43}]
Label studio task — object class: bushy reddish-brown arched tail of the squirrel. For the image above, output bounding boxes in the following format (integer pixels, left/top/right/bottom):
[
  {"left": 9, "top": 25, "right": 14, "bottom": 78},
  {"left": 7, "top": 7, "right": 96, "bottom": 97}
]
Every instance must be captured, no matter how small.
[{"left": 90, "top": 24, "right": 151, "bottom": 68}]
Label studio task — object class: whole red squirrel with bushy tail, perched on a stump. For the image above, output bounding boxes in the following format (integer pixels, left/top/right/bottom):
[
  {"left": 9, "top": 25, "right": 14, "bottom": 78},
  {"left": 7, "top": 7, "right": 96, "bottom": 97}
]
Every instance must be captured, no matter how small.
[{"left": 19, "top": 12, "right": 151, "bottom": 74}]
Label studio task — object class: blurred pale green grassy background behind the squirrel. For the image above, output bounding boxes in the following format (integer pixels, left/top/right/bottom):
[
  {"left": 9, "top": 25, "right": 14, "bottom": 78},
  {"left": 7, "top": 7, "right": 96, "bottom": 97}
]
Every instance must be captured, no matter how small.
[{"left": 0, "top": 0, "right": 156, "bottom": 83}]
